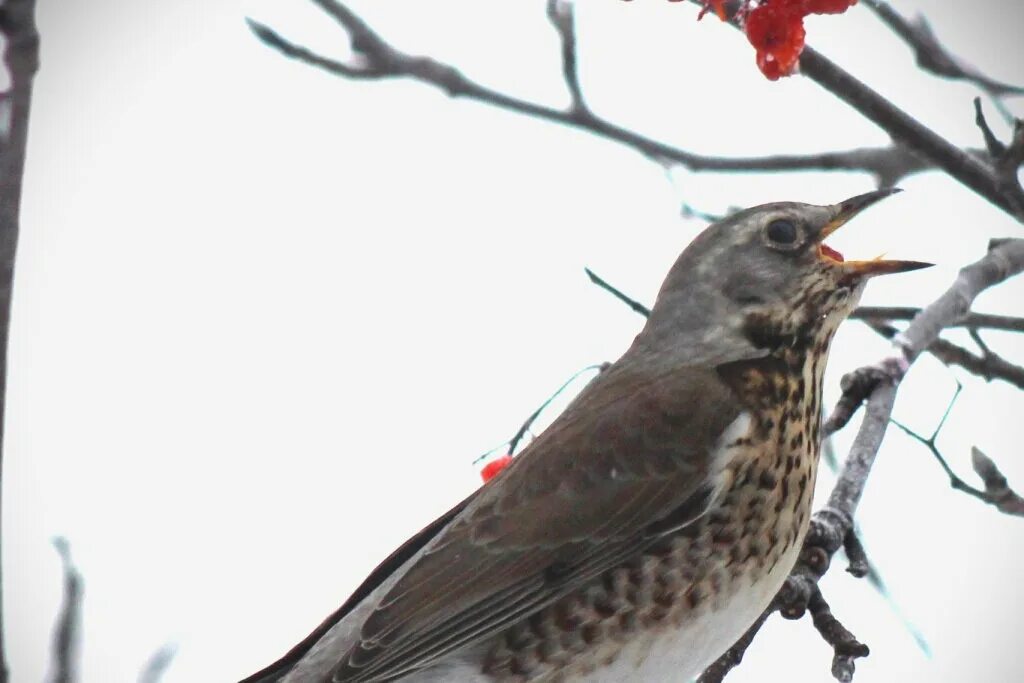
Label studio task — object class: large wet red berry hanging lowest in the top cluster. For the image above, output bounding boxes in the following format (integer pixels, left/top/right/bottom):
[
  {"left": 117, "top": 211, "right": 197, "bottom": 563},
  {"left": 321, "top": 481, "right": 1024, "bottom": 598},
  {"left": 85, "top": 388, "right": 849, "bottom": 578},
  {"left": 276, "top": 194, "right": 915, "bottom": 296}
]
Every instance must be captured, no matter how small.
[{"left": 744, "top": 2, "right": 805, "bottom": 81}]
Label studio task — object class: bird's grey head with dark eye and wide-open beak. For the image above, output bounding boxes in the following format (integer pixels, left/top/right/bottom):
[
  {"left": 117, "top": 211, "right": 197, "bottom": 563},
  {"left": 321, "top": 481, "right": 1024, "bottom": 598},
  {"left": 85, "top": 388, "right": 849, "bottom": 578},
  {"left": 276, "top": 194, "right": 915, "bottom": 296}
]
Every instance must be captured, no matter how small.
[{"left": 638, "top": 189, "right": 930, "bottom": 368}]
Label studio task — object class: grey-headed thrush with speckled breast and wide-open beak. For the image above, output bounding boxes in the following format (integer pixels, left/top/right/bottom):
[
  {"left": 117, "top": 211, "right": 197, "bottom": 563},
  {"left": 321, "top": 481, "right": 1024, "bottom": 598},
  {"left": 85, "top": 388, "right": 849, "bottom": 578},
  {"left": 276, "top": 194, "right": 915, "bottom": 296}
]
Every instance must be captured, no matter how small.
[{"left": 244, "top": 188, "right": 930, "bottom": 683}]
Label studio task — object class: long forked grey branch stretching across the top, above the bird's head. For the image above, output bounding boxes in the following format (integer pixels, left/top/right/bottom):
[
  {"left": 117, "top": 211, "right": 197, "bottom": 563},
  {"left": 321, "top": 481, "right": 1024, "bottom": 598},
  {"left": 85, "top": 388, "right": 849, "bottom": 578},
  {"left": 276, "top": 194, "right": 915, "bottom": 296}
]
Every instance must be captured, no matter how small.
[{"left": 243, "top": 0, "right": 987, "bottom": 186}]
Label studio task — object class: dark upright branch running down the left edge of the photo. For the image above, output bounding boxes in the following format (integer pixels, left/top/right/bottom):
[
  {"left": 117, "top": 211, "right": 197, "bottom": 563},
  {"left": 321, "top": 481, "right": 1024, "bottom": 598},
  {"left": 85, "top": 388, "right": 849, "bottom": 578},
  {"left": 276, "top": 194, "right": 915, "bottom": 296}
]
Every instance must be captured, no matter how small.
[{"left": 0, "top": 0, "right": 39, "bottom": 683}]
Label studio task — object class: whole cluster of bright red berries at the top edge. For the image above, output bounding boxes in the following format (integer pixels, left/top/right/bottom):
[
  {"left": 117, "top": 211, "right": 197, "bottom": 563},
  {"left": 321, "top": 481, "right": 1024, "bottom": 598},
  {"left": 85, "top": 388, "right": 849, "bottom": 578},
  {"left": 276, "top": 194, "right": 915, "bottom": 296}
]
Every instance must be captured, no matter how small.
[{"left": 705, "top": 0, "right": 857, "bottom": 81}]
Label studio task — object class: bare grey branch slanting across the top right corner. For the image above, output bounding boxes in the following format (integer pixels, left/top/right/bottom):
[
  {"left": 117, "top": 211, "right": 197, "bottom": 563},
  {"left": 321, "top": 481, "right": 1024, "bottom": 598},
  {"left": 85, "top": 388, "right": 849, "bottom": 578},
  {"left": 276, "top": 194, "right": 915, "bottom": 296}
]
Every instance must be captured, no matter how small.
[{"left": 864, "top": 0, "right": 1024, "bottom": 96}]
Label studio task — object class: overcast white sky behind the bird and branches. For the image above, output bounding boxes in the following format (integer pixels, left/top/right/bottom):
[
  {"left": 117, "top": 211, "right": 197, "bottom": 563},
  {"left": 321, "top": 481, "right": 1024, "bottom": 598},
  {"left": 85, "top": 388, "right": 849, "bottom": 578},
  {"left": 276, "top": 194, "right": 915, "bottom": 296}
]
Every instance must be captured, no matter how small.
[{"left": 3, "top": 0, "right": 1024, "bottom": 683}]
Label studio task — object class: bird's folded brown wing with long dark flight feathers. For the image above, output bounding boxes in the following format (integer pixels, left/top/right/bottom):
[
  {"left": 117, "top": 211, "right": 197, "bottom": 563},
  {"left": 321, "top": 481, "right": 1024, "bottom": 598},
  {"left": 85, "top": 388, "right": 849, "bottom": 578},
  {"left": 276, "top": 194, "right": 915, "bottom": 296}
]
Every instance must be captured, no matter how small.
[{"left": 334, "top": 366, "right": 739, "bottom": 683}]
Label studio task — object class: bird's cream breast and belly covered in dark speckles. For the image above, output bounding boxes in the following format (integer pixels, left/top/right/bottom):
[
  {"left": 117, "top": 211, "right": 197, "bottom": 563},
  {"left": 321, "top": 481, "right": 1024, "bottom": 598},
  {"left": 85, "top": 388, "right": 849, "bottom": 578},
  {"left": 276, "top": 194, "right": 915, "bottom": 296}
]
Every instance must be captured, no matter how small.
[{"left": 484, "top": 337, "right": 827, "bottom": 683}]
